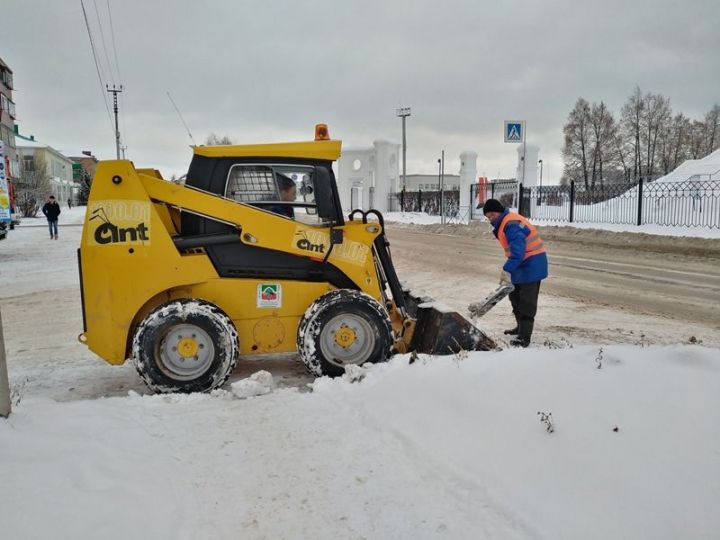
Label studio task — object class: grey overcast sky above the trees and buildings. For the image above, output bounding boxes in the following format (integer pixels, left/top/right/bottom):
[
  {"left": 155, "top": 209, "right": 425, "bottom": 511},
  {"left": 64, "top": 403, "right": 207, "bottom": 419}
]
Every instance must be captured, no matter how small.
[{"left": 0, "top": 0, "right": 720, "bottom": 182}]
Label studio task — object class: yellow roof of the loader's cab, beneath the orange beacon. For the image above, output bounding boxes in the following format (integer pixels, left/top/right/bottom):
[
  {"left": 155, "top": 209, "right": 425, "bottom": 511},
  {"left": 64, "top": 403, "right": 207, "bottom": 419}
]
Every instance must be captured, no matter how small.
[{"left": 192, "top": 140, "right": 342, "bottom": 161}]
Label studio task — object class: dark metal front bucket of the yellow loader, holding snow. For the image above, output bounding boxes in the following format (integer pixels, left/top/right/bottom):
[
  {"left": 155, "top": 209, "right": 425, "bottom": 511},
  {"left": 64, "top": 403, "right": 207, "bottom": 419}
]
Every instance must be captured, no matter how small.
[{"left": 404, "top": 291, "right": 497, "bottom": 354}]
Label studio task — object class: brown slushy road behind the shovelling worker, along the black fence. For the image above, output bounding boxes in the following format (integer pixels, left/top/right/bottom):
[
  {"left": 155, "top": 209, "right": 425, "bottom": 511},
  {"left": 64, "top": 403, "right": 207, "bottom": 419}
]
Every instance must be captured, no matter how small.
[{"left": 388, "top": 225, "right": 720, "bottom": 329}]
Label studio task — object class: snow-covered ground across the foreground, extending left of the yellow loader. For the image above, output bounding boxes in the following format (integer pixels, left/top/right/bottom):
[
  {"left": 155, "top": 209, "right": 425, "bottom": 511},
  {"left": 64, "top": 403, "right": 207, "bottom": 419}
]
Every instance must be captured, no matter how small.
[{"left": 0, "top": 205, "right": 720, "bottom": 540}]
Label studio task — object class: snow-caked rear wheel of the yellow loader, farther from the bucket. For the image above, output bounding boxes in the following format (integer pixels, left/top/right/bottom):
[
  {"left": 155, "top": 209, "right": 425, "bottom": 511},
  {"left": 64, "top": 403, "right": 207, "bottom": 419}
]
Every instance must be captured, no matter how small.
[{"left": 132, "top": 299, "right": 239, "bottom": 393}]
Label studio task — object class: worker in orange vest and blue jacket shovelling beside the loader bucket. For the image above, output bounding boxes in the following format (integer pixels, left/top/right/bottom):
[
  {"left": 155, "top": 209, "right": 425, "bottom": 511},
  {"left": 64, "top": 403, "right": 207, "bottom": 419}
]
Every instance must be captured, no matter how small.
[{"left": 483, "top": 199, "right": 548, "bottom": 347}]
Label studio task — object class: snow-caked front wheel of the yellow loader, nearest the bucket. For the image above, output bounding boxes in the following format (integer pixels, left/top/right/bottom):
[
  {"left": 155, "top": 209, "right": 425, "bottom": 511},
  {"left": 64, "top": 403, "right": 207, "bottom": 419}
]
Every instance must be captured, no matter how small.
[{"left": 297, "top": 289, "right": 393, "bottom": 377}]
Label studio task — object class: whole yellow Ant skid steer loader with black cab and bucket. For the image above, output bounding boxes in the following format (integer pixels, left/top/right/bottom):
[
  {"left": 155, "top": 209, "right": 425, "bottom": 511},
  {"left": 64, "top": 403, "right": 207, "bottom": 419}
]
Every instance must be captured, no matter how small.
[{"left": 78, "top": 127, "right": 494, "bottom": 392}]
